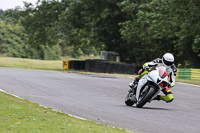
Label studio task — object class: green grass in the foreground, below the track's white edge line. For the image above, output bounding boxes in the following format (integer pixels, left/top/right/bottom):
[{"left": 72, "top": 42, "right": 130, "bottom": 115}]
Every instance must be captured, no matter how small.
[{"left": 0, "top": 92, "right": 128, "bottom": 133}]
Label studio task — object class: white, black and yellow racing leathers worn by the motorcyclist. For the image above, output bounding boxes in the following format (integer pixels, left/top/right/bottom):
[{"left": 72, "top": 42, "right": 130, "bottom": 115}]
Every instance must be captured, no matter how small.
[{"left": 133, "top": 58, "right": 177, "bottom": 102}]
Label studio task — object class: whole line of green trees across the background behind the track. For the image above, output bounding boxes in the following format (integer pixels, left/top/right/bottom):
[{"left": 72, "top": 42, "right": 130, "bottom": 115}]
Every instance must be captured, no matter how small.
[{"left": 0, "top": 0, "right": 200, "bottom": 68}]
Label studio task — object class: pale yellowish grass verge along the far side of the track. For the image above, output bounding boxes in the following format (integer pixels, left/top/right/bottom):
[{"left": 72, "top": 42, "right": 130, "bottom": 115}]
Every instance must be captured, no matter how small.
[{"left": 0, "top": 57, "right": 200, "bottom": 85}]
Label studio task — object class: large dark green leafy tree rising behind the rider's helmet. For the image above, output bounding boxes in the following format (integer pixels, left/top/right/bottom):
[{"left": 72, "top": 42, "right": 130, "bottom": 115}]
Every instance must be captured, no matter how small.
[{"left": 120, "top": 0, "right": 200, "bottom": 67}]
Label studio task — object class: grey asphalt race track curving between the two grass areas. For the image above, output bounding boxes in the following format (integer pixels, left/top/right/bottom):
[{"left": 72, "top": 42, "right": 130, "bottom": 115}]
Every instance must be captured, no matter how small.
[{"left": 0, "top": 68, "right": 200, "bottom": 133}]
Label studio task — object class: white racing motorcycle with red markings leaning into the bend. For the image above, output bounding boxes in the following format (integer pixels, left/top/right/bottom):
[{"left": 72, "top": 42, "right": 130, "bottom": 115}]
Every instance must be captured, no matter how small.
[{"left": 125, "top": 66, "right": 169, "bottom": 108}]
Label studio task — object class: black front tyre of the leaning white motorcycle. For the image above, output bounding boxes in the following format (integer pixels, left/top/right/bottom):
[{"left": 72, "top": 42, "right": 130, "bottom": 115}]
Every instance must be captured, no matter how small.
[{"left": 136, "top": 87, "right": 156, "bottom": 108}]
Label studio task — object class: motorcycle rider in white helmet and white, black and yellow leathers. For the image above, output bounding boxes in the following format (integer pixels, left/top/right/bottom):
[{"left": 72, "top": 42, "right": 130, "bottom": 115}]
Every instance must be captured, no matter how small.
[{"left": 129, "top": 53, "right": 177, "bottom": 102}]
